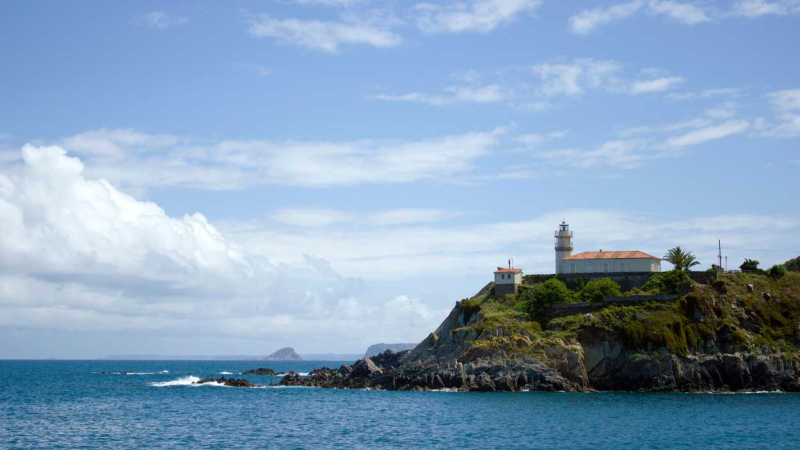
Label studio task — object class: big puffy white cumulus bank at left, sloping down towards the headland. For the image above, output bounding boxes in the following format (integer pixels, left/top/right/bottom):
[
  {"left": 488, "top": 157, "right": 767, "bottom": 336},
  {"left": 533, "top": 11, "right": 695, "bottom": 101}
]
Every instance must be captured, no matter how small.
[{"left": 0, "top": 145, "right": 446, "bottom": 354}]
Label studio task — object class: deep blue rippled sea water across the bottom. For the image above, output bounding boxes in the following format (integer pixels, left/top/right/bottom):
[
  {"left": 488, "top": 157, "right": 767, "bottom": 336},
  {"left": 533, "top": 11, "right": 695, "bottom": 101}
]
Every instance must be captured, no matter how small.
[{"left": 0, "top": 361, "right": 800, "bottom": 450}]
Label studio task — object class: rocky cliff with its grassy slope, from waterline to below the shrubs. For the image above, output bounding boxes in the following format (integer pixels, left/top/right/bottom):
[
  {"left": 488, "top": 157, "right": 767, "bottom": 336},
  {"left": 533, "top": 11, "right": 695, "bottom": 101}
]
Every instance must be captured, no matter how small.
[{"left": 281, "top": 274, "right": 800, "bottom": 392}]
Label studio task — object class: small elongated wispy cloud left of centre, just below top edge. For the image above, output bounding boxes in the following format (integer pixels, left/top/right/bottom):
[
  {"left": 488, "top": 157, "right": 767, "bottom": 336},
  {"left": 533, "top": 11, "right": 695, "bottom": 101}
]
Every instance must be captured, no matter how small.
[{"left": 248, "top": 15, "right": 402, "bottom": 53}]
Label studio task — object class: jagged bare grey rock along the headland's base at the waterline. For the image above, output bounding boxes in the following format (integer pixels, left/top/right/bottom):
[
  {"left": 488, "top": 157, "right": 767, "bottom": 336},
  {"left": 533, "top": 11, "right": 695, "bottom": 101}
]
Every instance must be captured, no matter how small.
[{"left": 277, "top": 280, "right": 800, "bottom": 392}]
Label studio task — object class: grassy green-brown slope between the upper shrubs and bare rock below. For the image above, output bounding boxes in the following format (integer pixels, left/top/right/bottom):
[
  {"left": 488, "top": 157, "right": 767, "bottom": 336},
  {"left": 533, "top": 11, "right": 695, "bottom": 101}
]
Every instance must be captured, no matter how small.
[{"left": 456, "top": 273, "right": 800, "bottom": 360}]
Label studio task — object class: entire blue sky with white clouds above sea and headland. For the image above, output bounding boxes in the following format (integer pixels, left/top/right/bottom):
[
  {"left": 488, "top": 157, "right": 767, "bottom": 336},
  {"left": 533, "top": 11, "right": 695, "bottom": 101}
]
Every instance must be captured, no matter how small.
[{"left": 0, "top": 0, "right": 800, "bottom": 358}]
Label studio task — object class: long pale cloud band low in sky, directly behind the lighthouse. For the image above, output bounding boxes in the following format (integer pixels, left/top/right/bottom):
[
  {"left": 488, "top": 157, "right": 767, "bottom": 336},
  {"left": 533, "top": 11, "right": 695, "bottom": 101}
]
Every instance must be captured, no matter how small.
[{"left": 225, "top": 208, "right": 800, "bottom": 285}]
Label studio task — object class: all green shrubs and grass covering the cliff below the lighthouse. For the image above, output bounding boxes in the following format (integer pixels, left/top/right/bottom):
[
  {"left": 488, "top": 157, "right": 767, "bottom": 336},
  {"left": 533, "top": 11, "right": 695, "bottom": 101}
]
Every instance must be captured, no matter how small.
[{"left": 462, "top": 271, "right": 800, "bottom": 356}]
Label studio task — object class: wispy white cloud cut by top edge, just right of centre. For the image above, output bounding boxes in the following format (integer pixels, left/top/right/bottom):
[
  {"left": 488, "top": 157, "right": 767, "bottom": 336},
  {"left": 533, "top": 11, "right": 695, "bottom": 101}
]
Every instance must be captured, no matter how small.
[{"left": 414, "top": 0, "right": 542, "bottom": 33}]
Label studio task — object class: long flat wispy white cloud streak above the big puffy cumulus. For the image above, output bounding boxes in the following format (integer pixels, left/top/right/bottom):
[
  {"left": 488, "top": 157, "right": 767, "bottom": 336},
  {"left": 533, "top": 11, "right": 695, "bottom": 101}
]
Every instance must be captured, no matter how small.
[{"left": 63, "top": 129, "right": 504, "bottom": 192}]
